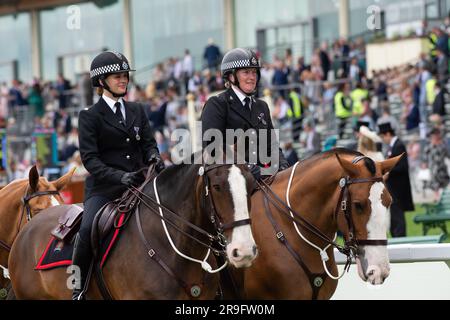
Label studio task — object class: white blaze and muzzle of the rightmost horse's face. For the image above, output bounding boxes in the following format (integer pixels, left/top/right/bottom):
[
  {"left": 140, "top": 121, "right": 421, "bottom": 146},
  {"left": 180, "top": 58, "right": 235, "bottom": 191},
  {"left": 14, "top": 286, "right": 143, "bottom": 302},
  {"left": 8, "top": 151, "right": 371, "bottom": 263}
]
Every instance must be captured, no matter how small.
[{"left": 356, "top": 182, "right": 390, "bottom": 284}]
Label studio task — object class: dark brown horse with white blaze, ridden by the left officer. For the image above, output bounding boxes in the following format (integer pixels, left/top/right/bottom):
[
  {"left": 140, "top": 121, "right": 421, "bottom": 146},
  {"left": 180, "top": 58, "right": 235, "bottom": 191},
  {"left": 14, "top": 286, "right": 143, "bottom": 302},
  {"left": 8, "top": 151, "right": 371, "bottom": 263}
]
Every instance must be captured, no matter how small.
[{"left": 9, "top": 164, "right": 257, "bottom": 300}]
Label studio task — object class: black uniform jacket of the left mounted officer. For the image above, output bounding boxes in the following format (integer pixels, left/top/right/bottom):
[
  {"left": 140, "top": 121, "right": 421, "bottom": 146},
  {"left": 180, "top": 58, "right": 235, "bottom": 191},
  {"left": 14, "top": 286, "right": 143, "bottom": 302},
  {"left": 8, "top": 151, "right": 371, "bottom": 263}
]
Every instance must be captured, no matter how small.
[{"left": 78, "top": 98, "right": 158, "bottom": 200}]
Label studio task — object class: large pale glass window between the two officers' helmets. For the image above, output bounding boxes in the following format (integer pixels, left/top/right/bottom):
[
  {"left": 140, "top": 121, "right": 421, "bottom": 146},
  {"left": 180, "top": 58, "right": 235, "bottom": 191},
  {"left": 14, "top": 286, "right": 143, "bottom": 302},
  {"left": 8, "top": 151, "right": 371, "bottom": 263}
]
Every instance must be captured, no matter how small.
[{"left": 131, "top": 0, "right": 224, "bottom": 83}]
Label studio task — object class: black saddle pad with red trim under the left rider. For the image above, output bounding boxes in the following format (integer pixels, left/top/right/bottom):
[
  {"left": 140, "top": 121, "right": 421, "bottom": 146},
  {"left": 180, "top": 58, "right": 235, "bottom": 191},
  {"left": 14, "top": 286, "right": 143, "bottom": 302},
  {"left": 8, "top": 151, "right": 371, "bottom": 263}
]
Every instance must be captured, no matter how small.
[{"left": 34, "top": 213, "right": 125, "bottom": 270}]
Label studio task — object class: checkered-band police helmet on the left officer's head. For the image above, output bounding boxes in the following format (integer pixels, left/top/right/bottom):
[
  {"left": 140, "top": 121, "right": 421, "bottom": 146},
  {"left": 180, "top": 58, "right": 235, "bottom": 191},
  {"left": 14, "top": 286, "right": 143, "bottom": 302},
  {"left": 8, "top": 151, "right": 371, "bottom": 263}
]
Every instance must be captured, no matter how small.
[{"left": 90, "top": 51, "right": 135, "bottom": 87}]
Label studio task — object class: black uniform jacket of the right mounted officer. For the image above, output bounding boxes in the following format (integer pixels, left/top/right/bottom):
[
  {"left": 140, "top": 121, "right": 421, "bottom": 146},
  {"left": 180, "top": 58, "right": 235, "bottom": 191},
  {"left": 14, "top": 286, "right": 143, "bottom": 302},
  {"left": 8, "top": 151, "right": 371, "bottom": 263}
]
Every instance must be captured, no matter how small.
[{"left": 201, "top": 88, "right": 288, "bottom": 166}]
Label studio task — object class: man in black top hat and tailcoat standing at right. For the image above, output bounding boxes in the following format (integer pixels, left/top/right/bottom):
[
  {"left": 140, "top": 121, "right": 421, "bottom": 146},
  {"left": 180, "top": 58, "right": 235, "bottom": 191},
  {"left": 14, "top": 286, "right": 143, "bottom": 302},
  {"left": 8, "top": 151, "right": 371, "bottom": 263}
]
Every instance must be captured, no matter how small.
[{"left": 378, "top": 122, "right": 414, "bottom": 237}]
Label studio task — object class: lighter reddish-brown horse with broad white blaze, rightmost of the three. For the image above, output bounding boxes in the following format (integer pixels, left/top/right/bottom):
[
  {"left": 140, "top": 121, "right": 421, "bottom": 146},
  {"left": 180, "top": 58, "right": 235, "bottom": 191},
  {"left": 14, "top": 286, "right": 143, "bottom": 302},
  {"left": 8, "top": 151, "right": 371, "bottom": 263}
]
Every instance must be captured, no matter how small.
[{"left": 237, "top": 149, "right": 401, "bottom": 299}]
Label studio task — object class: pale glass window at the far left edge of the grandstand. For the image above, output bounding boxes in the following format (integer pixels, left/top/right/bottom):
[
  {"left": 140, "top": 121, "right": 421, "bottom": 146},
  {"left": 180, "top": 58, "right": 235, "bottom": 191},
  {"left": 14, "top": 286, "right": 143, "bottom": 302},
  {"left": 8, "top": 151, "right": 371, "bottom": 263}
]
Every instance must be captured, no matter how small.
[{"left": 0, "top": 13, "right": 32, "bottom": 82}]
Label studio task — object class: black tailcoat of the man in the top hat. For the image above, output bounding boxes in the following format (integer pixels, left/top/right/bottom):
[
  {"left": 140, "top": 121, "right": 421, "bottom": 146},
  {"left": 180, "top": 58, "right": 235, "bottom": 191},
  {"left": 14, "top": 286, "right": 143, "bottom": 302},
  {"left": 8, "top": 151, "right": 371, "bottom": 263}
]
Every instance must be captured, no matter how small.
[{"left": 386, "top": 139, "right": 414, "bottom": 211}]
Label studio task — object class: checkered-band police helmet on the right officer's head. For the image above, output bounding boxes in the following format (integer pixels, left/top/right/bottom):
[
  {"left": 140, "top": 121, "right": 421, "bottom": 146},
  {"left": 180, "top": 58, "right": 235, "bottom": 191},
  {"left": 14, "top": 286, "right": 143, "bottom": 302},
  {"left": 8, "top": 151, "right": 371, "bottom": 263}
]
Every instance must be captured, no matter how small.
[{"left": 220, "top": 48, "right": 261, "bottom": 76}]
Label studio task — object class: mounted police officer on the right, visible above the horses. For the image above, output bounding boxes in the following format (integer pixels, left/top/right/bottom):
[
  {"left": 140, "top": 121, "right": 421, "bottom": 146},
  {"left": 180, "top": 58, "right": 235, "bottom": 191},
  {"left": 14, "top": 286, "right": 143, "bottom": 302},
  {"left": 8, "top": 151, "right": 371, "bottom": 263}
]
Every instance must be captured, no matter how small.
[{"left": 201, "top": 48, "right": 289, "bottom": 179}]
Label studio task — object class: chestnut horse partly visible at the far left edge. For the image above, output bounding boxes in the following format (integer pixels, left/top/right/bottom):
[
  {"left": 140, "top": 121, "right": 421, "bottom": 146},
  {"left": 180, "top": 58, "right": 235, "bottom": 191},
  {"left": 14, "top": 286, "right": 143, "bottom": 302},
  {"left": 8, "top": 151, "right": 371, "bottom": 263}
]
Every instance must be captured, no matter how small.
[{"left": 0, "top": 166, "right": 73, "bottom": 298}]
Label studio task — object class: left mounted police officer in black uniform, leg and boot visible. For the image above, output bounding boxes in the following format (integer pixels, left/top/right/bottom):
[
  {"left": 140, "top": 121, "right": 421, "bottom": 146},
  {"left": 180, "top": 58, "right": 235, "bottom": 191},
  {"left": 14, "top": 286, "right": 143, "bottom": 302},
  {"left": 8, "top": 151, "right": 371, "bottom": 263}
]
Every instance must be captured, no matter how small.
[{"left": 72, "top": 51, "right": 164, "bottom": 300}]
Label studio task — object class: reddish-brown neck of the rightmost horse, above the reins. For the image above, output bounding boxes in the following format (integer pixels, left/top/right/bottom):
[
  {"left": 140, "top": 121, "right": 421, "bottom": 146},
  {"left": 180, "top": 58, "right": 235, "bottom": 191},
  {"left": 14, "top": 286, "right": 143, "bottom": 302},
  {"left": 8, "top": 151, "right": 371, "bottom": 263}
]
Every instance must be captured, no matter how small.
[{"left": 272, "top": 159, "right": 341, "bottom": 237}]
